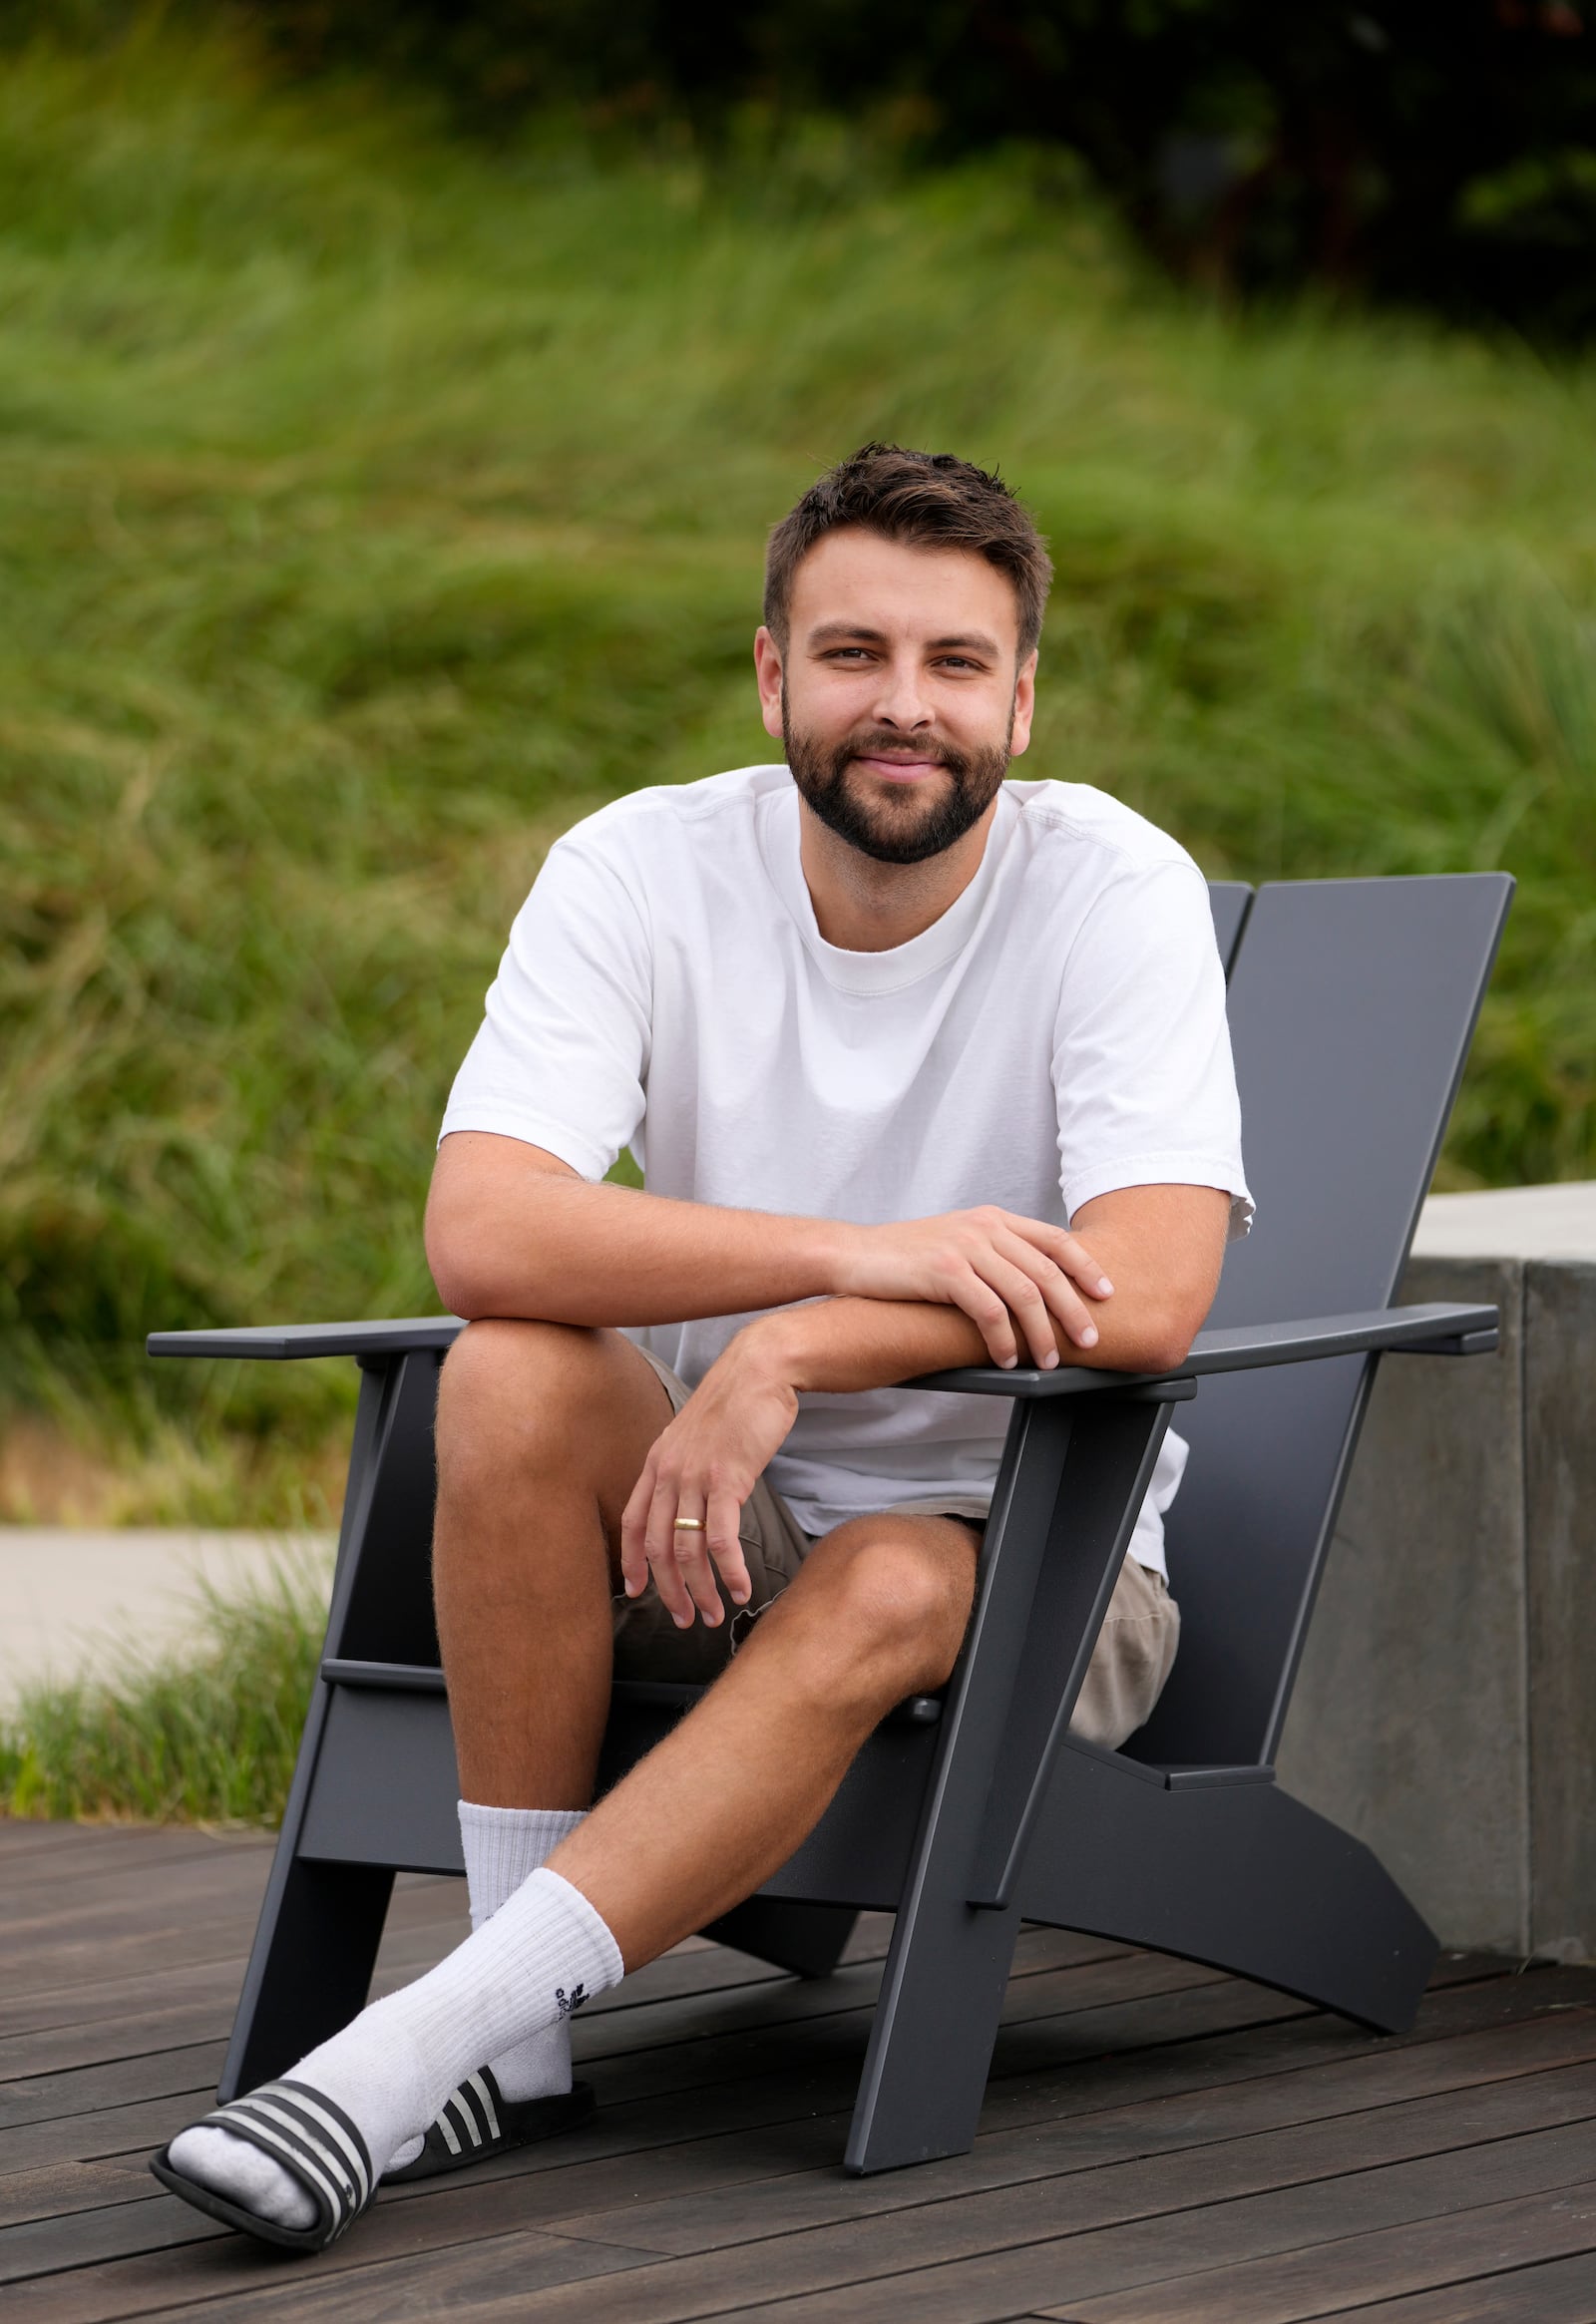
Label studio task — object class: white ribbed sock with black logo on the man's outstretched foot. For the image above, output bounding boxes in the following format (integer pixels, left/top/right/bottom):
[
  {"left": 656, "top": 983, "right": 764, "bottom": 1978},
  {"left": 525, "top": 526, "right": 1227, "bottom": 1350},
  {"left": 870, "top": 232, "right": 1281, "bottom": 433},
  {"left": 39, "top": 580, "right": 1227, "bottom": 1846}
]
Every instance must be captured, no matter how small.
[{"left": 172, "top": 1866, "right": 622, "bottom": 2226}]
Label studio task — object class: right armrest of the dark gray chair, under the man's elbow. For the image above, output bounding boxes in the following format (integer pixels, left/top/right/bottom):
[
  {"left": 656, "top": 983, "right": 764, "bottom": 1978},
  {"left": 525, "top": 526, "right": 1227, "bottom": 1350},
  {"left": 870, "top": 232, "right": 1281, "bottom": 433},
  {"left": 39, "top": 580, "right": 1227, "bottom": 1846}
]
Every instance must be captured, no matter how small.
[{"left": 906, "top": 1302, "right": 1501, "bottom": 1396}]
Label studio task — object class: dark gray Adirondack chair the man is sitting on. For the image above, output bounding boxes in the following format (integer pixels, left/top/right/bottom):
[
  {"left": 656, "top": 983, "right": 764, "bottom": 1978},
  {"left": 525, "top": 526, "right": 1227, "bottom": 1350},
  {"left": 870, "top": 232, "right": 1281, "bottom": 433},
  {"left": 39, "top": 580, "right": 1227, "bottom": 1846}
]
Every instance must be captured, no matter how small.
[{"left": 149, "top": 876, "right": 1510, "bottom": 2170}]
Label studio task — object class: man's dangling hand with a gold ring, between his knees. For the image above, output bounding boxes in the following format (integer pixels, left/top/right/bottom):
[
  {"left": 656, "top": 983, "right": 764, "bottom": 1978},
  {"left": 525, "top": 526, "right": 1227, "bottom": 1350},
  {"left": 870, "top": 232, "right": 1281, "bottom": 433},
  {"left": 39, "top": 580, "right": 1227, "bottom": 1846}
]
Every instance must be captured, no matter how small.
[{"left": 620, "top": 1325, "right": 797, "bottom": 1629}]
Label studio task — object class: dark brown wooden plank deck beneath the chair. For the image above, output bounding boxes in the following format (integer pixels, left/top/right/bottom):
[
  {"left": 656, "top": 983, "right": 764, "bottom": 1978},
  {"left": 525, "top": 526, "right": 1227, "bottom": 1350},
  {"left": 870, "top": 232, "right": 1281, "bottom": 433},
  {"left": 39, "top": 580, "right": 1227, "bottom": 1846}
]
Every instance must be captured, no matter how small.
[{"left": 0, "top": 1824, "right": 1596, "bottom": 2324}]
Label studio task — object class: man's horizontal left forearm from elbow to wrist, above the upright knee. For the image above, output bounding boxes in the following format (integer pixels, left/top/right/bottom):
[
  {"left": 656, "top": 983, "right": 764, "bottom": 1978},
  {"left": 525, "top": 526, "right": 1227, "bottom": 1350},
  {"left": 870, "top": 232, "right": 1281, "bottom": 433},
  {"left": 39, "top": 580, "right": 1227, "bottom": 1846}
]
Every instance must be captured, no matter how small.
[{"left": 428, "top": 1139, "right": 848, "bottom": 1325}]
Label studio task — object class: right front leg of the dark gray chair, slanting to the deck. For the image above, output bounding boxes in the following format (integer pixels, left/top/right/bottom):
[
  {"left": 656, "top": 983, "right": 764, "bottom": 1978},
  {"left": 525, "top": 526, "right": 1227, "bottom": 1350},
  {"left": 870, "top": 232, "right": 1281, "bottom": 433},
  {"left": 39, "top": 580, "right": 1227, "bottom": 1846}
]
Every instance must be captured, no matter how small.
[{"left": 846, "top": 1392, "right": 1168, "bottom": 2173}]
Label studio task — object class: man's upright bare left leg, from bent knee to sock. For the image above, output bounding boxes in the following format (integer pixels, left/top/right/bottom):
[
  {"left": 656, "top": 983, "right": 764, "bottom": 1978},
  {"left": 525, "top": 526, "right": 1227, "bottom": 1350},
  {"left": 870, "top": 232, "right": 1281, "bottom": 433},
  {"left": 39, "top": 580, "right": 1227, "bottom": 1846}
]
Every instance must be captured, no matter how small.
[{"left": 432, "top": 1323, "right": 671, "bottom": 1808}]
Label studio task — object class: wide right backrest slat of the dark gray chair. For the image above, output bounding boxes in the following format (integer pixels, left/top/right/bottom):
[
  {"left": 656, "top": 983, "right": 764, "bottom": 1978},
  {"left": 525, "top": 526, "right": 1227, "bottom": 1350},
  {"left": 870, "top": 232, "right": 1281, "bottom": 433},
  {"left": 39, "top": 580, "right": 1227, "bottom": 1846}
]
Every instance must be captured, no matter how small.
[{"left": 1131, "top": 874, "right": 1512, "bottom": 1763}]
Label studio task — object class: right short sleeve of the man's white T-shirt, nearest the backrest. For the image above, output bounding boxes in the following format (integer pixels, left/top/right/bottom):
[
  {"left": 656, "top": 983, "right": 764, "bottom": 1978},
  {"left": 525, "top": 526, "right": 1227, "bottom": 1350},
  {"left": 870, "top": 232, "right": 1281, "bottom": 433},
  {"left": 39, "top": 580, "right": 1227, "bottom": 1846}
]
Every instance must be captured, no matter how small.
[{"left": 1052, "top": 862, "right": 1252, "bottom": 1234}]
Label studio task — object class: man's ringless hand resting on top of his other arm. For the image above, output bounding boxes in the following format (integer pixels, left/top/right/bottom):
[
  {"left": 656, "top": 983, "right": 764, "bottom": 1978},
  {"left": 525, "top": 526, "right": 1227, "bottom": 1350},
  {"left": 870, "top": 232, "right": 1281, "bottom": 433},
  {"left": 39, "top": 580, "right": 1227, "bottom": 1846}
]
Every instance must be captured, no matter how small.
[{"left": 836, "top": 1204, "right": 1113, "bottom": 1371}]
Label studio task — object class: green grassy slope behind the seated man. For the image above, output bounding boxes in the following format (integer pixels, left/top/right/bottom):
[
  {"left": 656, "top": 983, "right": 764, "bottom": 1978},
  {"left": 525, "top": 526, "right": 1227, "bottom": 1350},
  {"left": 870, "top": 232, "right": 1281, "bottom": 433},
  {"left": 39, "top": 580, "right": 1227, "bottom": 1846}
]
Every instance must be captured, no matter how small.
[{"left": 0, "top": 47, "right": 1596, "bottom": 1515}]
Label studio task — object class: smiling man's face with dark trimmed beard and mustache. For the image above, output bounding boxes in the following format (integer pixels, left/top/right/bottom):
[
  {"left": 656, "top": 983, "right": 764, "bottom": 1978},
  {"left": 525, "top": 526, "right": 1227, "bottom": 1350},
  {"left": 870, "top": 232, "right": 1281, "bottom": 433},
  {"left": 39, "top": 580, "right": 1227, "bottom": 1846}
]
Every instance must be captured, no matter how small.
[{"left": 755, "top": 530, "right": 1036, "bottom": 865}]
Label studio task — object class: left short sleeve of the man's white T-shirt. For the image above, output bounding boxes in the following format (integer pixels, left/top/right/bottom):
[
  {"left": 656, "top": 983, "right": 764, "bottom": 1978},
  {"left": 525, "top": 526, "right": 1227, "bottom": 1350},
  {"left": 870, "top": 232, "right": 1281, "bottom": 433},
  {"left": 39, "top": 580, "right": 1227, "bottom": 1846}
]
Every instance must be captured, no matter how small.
[{"left": 439, "top": 839, "right": 652, "bottom": 1178}]
